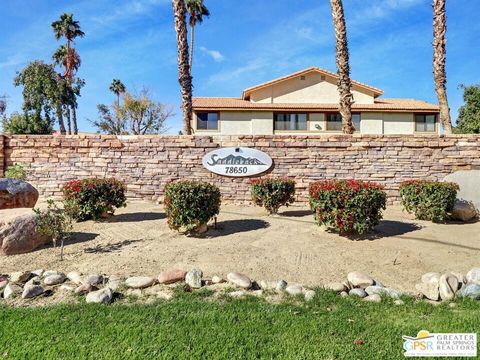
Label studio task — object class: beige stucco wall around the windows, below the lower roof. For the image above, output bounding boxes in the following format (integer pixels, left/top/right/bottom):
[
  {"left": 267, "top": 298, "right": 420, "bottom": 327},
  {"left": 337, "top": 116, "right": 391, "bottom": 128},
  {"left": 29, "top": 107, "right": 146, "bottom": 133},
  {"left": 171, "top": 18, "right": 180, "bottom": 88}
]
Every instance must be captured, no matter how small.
[{"left": 194, "top": 111, "right": 439, "bottom": 135}]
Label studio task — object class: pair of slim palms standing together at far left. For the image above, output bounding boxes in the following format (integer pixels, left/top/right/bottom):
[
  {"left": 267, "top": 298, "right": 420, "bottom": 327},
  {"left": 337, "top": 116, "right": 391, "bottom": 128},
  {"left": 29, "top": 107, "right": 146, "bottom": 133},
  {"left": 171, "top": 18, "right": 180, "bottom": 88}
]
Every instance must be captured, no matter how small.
[{"left": 52, "top": 13, "right": 85, "bottom": 134}]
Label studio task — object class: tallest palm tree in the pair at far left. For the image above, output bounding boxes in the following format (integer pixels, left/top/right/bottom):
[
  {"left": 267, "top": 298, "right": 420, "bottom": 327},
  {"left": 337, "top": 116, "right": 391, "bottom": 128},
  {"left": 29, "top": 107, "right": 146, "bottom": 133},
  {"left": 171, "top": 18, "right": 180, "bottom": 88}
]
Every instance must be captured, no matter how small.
[{"left": 52, "top": 13, "right": 85, "bottom": 134}]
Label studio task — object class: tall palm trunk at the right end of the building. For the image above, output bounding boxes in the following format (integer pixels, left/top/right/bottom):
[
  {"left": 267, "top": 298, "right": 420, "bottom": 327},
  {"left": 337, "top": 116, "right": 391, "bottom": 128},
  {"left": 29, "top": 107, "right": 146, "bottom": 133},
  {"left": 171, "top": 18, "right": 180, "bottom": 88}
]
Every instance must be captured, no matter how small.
[{"left": 433, "top": 0, "right": 452, "bottom": 134}]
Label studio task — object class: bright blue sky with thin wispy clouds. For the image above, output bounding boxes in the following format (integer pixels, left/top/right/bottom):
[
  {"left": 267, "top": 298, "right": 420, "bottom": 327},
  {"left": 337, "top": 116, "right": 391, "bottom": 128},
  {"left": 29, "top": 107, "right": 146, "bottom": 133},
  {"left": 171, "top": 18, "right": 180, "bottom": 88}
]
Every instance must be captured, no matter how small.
[{"left": 0, "top": 0, "right": 480, "bottom": 133}]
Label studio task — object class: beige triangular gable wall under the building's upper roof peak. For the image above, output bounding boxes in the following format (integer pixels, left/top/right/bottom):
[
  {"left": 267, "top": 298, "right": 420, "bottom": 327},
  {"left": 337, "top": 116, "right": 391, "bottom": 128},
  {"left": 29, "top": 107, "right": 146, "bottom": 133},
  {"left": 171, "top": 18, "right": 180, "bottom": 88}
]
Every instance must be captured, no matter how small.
[{"left": 250, "top": 73, "right": 374, "bottom": 104}]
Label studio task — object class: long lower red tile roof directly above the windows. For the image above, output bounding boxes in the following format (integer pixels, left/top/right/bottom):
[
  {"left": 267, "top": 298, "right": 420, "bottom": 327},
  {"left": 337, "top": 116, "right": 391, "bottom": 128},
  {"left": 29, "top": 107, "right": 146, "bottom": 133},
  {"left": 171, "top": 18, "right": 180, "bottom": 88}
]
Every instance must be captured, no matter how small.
[{"left": 193, "top": 97, "right": 439, "bottom": 112}]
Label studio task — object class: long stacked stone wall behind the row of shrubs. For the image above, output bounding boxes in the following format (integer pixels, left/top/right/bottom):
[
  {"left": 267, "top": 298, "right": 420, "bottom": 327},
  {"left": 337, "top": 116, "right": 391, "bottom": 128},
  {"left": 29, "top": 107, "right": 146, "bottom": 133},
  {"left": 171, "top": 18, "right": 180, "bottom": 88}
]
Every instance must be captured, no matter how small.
[{"left": 0, "top": 135, "right": 480, "bottom": 203}]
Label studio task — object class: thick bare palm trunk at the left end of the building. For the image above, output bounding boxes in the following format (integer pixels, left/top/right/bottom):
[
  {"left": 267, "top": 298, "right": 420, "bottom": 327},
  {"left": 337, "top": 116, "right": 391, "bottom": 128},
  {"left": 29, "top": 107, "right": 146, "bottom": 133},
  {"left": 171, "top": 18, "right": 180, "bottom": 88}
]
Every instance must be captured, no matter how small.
[{"left": 172, "top": 0, "right": 192, "bottom": 135}]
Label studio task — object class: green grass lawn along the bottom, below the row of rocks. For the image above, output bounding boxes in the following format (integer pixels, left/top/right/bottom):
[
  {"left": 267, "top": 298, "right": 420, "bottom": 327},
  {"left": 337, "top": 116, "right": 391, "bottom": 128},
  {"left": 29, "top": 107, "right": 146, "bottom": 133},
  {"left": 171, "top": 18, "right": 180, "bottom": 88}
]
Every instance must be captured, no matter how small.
[{"left": 0, "top": 291, "right": 480, "bottom": 359}]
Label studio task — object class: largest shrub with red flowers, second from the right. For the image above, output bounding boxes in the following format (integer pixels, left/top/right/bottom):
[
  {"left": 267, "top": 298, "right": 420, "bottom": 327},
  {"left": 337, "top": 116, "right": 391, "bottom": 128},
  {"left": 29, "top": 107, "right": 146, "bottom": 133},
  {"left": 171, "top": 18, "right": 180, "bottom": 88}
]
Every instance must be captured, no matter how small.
[{"left": 309, "top": 180, "right": 387, "bottom": 234}]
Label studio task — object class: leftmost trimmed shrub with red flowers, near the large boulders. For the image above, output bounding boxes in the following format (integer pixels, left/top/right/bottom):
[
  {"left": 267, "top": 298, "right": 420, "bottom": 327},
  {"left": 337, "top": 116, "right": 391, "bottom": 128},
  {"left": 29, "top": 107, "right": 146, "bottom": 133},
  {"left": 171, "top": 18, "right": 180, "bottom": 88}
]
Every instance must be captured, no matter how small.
[{"left": 63, "top": 178, "right": 127, "bottom": 221}]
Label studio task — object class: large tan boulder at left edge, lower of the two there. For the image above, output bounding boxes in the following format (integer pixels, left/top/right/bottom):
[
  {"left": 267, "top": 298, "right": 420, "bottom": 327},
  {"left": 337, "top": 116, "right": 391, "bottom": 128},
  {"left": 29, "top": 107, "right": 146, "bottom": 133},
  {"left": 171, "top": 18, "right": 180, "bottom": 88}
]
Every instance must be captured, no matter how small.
[{"left": 0, "top": 208, "right": 51, "bottom": 255}]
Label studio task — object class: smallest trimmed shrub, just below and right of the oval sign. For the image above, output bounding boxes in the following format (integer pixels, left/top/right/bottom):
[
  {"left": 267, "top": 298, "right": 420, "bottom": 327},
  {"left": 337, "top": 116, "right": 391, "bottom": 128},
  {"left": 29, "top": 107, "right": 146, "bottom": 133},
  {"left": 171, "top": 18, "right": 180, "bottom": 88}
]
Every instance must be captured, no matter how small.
[{"left": 250, "top": 178, "right": 295, "bottom": 214}]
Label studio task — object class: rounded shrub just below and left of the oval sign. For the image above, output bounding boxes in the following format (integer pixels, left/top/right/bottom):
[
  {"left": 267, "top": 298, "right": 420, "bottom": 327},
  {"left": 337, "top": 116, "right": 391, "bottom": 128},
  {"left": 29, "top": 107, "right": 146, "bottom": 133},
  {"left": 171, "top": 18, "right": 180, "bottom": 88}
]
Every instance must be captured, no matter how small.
[{"left": 165, "top": 181, "right": 221, "bottom": 231}]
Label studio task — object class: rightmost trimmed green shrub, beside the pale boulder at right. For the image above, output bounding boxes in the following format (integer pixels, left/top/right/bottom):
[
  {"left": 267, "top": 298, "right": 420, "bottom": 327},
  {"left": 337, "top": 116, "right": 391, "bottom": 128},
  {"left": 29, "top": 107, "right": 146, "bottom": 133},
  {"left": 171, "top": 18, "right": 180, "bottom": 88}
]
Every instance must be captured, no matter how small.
[{"left": 400, "top": 180, "right": 459, "bottom": 222}]
